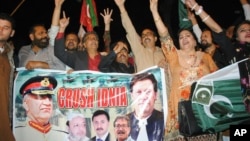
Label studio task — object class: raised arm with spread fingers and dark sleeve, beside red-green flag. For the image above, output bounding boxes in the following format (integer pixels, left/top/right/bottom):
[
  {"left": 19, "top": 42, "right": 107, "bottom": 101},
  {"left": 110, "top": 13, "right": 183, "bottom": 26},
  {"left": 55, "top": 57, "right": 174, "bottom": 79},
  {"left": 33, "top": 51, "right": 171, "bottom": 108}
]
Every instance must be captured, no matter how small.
[{"left": 100, "top": 8, "right": 113, "bottom": 53}]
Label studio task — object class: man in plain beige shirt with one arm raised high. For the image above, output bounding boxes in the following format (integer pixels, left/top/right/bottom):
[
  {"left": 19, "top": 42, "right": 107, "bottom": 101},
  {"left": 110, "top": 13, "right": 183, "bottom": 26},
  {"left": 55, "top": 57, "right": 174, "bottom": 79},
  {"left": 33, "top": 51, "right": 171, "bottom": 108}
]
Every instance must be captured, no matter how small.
[{"left": 114, "top": 0, "right": 167, "bottom": 72}]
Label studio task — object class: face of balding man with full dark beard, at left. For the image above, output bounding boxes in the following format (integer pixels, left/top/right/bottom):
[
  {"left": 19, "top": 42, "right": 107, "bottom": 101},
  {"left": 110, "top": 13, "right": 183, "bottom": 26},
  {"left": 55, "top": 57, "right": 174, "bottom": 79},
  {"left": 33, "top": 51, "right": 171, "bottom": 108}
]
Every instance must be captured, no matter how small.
[{"left": 30, "top": 26, "right": 49, "bottom": 48}]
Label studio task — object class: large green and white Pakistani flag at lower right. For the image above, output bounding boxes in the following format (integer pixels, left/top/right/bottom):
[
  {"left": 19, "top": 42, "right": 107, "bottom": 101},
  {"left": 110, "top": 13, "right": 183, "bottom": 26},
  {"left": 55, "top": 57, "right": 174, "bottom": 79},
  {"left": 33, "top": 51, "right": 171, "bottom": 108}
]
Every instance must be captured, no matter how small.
[{"left": 192, "top": 60, "right": 250, "bottom": 132}]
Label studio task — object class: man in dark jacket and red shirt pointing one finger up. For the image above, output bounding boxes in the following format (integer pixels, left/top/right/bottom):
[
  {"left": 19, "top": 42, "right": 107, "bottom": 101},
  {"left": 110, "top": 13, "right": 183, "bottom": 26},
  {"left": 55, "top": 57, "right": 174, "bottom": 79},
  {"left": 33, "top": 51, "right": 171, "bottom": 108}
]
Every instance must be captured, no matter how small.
[{"left": 54, "top": 13, "right": 103, "bottom": 71}]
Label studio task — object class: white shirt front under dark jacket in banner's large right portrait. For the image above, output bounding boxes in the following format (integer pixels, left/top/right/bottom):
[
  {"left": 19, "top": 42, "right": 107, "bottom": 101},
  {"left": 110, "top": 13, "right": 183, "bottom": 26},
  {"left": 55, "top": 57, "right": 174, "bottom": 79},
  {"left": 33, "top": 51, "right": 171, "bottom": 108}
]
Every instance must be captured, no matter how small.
[{"left": 137, "top": 119, "right": 148, "bottom": 141}]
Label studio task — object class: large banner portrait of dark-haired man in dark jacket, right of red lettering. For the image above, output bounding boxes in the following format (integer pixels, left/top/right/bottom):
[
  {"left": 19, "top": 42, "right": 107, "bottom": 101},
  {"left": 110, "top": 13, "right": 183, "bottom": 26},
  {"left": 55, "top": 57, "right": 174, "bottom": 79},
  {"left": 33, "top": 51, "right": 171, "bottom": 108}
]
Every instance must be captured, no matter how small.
[{"left": 127, "top": 72, "right": 164, "bottom": 141}]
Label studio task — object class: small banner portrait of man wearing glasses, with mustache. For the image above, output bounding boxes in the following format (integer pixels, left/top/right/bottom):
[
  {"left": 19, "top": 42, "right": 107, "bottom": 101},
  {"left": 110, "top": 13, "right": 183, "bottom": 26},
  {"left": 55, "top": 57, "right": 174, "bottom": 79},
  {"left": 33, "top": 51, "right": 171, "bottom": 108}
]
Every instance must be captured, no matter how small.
[{"left": 114, "top": 115, "right": 133, "bottom": 141}]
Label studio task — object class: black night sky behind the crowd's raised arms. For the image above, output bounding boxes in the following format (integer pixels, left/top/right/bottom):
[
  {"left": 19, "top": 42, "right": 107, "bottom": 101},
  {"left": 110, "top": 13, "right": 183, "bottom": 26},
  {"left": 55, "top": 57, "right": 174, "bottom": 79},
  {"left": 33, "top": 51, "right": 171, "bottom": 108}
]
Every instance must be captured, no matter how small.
[{"left": 0, "top": 0, "right": 242, "bottom": 50}]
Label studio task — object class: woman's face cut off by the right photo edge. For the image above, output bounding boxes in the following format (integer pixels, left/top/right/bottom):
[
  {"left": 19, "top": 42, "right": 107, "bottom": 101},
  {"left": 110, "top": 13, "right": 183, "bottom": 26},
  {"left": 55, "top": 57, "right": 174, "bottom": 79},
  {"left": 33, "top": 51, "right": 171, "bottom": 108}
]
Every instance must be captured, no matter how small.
[{"left": 237, "top": 24, "right": 250, "bottom": 43}]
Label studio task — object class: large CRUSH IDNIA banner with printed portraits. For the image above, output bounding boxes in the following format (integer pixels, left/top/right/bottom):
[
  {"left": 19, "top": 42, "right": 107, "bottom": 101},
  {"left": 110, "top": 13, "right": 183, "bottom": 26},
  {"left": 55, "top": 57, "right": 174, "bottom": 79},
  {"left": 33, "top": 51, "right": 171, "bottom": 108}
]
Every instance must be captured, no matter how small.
[{"left": 13, "top": 67, "right": 167, "bottom": 141}]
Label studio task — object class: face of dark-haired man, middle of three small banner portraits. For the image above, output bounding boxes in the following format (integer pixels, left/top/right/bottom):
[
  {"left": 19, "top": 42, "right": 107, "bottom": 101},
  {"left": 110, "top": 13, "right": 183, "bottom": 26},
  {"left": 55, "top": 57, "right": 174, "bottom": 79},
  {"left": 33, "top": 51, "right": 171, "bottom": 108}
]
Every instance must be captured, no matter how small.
[{"left": 93, "top": 114, "right": 109, "bottom": 137}]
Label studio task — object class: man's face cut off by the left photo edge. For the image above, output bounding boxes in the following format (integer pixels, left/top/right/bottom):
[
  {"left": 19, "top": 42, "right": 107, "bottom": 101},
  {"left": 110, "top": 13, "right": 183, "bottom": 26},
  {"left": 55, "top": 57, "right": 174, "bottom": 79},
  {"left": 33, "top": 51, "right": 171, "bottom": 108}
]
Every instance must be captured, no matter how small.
[{"left": 0, "top": 19, "right": 15, "bottom": 42}]
